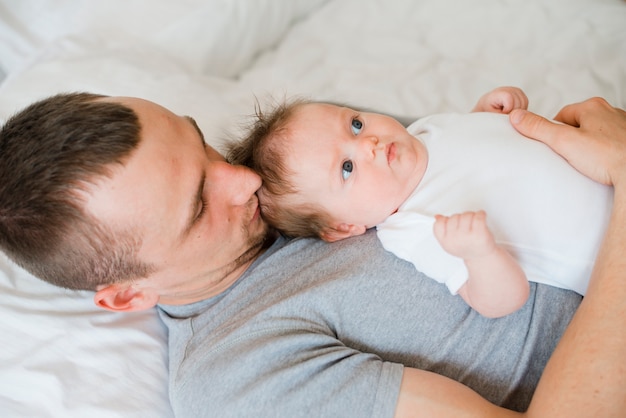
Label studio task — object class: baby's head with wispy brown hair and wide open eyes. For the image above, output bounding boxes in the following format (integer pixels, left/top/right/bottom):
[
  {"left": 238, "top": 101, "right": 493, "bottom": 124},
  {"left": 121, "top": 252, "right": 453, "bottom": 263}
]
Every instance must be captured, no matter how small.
[{"left": 228, "top": 100, "right": 427, "bottom": 241}]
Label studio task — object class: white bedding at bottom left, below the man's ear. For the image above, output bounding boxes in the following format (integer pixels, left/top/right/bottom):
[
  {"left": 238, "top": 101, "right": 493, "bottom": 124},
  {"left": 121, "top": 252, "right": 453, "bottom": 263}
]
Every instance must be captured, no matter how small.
[{"left": 0, "top": 253, "right": 173, "bottom": 418}]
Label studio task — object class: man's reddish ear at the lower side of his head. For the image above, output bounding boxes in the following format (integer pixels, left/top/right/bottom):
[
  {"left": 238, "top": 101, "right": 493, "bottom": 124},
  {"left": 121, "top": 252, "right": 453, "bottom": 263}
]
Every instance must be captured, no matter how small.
[{"left": 93, "top": 283, "right": 159, "bottom": 312}]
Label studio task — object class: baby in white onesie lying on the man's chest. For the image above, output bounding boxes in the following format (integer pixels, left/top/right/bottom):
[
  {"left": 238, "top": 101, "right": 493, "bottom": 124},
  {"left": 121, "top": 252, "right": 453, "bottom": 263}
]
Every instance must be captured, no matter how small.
[{"left": 228, "top": 87, "right": 612, "bottom": 317}]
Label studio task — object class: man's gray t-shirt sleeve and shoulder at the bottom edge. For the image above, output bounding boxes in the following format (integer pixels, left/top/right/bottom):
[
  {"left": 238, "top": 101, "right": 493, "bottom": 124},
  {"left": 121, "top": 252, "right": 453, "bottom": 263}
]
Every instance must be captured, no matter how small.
[{"left": 171, "top": 327, "right": 403, "bottom": 418}]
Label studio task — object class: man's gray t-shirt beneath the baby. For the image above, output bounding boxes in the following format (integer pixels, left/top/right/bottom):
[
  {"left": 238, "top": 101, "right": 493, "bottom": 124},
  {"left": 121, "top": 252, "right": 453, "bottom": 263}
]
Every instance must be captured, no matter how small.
[{"left": 161, "top": 232, "right": 581, "bottom": 418}]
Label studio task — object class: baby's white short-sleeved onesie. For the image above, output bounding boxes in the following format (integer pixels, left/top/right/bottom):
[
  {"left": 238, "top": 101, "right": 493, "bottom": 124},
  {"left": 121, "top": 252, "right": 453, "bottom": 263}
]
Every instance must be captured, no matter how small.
[{"left": 377, "top": 113, "right": 613, "bottom": 295}]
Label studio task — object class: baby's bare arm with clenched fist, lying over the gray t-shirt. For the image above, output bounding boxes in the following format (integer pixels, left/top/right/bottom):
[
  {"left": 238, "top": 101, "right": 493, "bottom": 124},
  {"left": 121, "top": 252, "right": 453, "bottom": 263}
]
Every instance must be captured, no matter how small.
[{"left": 434, "top": 211, "right": 529, "bottom": 318}]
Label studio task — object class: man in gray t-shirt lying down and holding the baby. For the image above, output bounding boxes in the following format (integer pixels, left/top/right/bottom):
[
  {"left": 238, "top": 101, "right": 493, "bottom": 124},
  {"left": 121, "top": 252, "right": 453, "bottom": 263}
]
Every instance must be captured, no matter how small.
[{"left": 0, "top": 95, "right": 626, "bottom": 417}]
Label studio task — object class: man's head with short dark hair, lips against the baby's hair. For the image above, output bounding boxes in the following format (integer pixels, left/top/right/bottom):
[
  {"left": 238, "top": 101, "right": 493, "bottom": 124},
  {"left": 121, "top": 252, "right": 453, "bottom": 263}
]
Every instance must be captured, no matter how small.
[{"left": 0, "top": 95, "right": 267, "bottom": 310}]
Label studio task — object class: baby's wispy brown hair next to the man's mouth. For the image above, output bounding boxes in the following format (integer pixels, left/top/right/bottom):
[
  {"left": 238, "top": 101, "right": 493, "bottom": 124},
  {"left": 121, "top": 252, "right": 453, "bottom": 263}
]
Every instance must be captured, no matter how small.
[{"left": 226, "top": 98, "right": 330, "bottom": 237}]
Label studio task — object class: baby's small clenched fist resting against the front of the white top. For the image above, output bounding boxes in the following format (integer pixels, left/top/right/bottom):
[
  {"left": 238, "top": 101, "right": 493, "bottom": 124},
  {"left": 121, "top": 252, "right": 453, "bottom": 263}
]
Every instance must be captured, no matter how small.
[{"left": 433, "top": 210, "right": 496, "bottom": 259}]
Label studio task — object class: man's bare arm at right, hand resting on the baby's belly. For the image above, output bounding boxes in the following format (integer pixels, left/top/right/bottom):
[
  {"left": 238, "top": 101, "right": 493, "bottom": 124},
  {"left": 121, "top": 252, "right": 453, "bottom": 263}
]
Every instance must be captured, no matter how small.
[{"left": 511, "top": 98, "right": 626, "bottom": 418}]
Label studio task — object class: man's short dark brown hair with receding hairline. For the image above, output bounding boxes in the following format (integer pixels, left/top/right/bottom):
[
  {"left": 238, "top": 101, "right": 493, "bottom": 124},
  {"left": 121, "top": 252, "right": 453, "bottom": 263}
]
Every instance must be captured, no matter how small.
[{"left": 0, "top": 93, "right": 150, "bottom": 290}]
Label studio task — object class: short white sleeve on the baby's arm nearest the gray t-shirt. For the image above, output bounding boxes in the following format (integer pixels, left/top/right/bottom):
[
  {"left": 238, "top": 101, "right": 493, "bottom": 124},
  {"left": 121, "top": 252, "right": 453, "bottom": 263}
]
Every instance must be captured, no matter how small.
[{"left": 376, "top": 212, "right": 468, "bottom": 295}]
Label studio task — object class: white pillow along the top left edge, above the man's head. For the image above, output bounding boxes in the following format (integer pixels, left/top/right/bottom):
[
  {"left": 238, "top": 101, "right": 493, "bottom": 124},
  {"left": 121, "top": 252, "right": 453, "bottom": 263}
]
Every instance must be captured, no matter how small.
[{"left": 0, "top": 0, "right": 327, "bottom": 77}]
